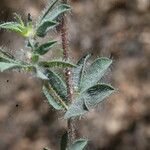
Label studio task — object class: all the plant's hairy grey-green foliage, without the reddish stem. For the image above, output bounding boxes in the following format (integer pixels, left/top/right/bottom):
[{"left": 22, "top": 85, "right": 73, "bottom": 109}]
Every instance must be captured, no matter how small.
[{"left": 0, "top": 0, "right": 115, "bottom": 150}]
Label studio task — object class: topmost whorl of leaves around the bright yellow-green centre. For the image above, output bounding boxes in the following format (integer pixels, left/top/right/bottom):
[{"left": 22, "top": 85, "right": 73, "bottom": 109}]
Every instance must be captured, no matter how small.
[{"left": 0, "top": 0, "right": 71, "bottom": 37}]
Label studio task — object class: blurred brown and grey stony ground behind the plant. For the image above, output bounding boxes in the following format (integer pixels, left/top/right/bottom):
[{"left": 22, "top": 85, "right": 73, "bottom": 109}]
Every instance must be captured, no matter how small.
[{"left": 0, "top": 0, "right": 150, "bottom": 150}]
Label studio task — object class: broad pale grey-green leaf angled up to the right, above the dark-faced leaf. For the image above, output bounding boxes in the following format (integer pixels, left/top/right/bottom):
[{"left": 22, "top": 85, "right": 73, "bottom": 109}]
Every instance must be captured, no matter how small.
[{"left": 81, "top": 58, "right": 112, "bottom": 91}]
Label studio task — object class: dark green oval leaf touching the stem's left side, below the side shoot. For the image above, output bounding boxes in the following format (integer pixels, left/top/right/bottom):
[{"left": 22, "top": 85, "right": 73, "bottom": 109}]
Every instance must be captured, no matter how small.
[{"left": 45, "top": 70, "right": 67, "bottom": 100}]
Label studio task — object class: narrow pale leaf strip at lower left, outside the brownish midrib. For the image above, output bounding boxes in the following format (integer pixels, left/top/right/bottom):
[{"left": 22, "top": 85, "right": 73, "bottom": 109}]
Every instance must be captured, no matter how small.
[{"left": 43, "top": 86, "right": 63, "bottom": 110}]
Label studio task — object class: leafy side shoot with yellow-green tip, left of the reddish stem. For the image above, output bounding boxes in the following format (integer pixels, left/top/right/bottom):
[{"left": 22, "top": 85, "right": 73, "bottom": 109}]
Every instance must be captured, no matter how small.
[{"left": 0, "top": 0, "right": 75, "bottom": 80}]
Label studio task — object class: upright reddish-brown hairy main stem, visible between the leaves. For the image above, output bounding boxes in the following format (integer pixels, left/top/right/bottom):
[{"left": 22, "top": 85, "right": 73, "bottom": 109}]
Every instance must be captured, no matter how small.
[{"left": 61, "top": 0, "right": 75, "bottom": 145}]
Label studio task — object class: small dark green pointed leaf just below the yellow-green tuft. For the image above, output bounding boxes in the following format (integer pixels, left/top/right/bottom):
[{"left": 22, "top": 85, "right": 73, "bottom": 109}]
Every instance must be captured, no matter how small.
[{"left": 34, "top": 41, "right": 57, "bottom": 55}]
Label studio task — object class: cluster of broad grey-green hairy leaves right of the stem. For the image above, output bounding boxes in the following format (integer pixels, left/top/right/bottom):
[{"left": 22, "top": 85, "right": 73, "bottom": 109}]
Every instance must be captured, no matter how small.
[{"left": 65, "top": 54, "right": 115, "bottom": 119}]
